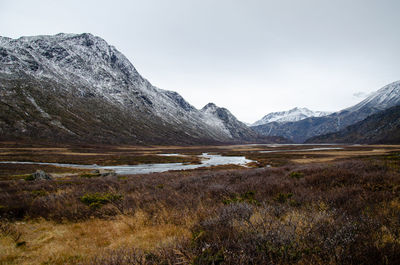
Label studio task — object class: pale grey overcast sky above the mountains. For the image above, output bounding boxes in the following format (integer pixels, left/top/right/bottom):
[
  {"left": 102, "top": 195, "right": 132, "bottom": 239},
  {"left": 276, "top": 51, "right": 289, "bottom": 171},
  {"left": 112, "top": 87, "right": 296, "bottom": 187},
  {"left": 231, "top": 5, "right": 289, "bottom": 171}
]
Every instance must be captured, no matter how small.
[{"left": 0, "top": 0, "right": 400, "bottom": 122}]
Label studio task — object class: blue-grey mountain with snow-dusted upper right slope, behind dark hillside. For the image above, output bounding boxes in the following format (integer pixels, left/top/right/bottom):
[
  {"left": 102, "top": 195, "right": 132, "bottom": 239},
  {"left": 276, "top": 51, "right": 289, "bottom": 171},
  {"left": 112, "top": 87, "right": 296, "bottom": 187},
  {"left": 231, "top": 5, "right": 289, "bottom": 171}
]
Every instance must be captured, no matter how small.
[{"left": 252, "top": 81, "right": 400, "bottom": 143}]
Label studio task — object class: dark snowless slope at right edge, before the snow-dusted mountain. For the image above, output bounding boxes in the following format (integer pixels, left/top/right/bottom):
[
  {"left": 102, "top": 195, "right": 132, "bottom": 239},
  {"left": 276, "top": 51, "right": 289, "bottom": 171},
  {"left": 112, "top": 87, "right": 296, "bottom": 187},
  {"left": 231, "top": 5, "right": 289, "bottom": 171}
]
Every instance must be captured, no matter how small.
[{"left": 306, "top": 105, "right": 400, "bottom": 144}]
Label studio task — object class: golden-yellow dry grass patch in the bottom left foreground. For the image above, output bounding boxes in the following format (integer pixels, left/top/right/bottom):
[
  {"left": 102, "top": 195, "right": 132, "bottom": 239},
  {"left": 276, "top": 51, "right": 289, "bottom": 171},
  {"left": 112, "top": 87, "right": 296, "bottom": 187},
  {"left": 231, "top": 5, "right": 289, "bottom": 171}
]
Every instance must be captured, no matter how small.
[{"left": 0, "top": 212, "right": 191, "bottom": 265}]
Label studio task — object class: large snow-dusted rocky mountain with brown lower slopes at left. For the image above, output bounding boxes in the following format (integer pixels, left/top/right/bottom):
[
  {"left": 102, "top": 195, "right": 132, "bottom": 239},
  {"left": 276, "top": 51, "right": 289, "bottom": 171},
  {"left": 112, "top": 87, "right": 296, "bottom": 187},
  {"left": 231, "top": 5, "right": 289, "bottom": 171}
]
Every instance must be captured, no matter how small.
[{"left": 0, "top": 33, "right": 268, "bottom": 144}]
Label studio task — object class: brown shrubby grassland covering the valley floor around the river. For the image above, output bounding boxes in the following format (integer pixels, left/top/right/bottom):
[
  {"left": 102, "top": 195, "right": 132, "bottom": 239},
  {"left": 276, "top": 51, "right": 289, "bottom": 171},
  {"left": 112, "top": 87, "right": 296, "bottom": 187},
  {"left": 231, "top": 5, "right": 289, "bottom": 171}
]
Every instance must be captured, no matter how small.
[{"left": 0, "top": 142, "right": 400, "bottom": 265}]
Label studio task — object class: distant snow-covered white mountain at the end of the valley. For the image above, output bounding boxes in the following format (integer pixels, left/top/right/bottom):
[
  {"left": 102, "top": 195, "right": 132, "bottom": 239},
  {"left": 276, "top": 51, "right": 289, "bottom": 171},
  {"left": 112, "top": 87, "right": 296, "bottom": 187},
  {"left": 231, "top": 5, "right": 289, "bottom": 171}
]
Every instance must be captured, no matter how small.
[{"left": 251, "top": 108, "right": 330, "bottom": 126}]
